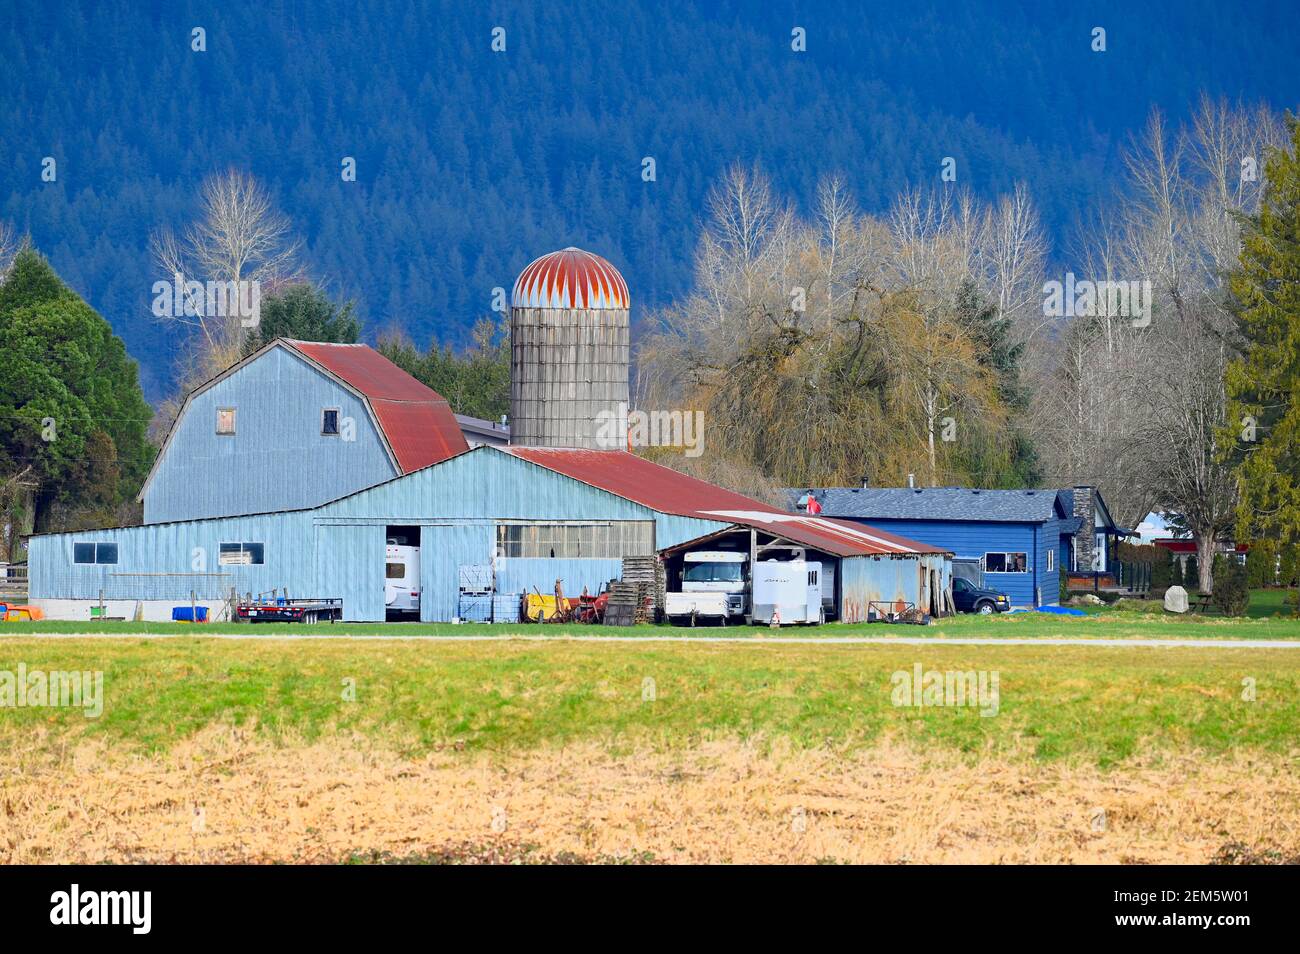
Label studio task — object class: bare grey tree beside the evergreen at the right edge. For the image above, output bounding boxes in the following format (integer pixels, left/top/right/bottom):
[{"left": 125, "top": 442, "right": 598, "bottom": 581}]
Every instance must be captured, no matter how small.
[{"left": 1035, "top": 97, "right": 1283, "bottom": 590}]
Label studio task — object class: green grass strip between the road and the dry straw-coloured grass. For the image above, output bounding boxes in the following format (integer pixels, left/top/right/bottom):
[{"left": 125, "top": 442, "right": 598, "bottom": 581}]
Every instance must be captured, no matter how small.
[{"left": 0, "top": 634, "right": 1300, "bottom": 766}]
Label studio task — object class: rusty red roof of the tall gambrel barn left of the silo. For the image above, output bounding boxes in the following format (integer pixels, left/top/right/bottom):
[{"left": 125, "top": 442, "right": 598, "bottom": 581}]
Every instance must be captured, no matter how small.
[{"left": 282, "top": 338, "right": 469, "bottom": 473}]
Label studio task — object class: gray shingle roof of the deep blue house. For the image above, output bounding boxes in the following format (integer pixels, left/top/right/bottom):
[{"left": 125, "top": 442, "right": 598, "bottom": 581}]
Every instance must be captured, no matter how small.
[{"left": 790, "top": 487, "right": 1070, "bottom": 522}]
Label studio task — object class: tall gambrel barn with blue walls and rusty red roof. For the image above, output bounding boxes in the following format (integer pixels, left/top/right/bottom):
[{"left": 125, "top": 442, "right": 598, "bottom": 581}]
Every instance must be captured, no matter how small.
[{"left": 138, "top": 338, "right": 468, "bottom": 524}]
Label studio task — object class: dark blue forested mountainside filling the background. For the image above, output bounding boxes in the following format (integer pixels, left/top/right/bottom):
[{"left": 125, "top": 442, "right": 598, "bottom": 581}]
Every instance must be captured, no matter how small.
[{"left": 0, "top": 0, "right": 1300, "bottom": 399}]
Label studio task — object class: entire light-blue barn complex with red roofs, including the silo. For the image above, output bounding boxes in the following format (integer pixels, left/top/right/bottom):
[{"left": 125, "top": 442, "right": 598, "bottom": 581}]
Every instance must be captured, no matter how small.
[{"left": 29, "top": 248, "right": 952, "bottom": 621}]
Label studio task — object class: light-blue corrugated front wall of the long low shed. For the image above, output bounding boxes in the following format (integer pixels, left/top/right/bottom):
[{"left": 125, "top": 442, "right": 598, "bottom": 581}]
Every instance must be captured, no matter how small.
[{"left": 30, "top": 447, "right": 725, "bottom": 620}]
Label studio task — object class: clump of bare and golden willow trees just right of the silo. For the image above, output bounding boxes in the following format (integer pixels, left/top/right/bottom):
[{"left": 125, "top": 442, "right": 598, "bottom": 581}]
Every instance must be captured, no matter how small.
[{"left": 637, "top": 169, "right": 1024, "bottom": 485}]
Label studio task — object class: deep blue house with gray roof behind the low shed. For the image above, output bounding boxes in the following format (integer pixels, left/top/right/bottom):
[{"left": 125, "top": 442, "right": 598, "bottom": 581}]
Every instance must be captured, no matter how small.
[{"left": 790, "top": 486, "right": 1132, "bottom": 607}]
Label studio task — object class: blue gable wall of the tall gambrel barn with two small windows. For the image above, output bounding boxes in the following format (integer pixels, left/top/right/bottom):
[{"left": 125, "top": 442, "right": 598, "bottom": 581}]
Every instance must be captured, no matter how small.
[{"left": 144, "top": 347, "right": 395, "bottom": 524}]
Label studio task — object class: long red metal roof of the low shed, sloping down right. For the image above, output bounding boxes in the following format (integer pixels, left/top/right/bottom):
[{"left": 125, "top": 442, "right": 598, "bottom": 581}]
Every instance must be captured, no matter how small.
[{"left": 506, "top": 447, "right": 948, "bottom": 556}]
